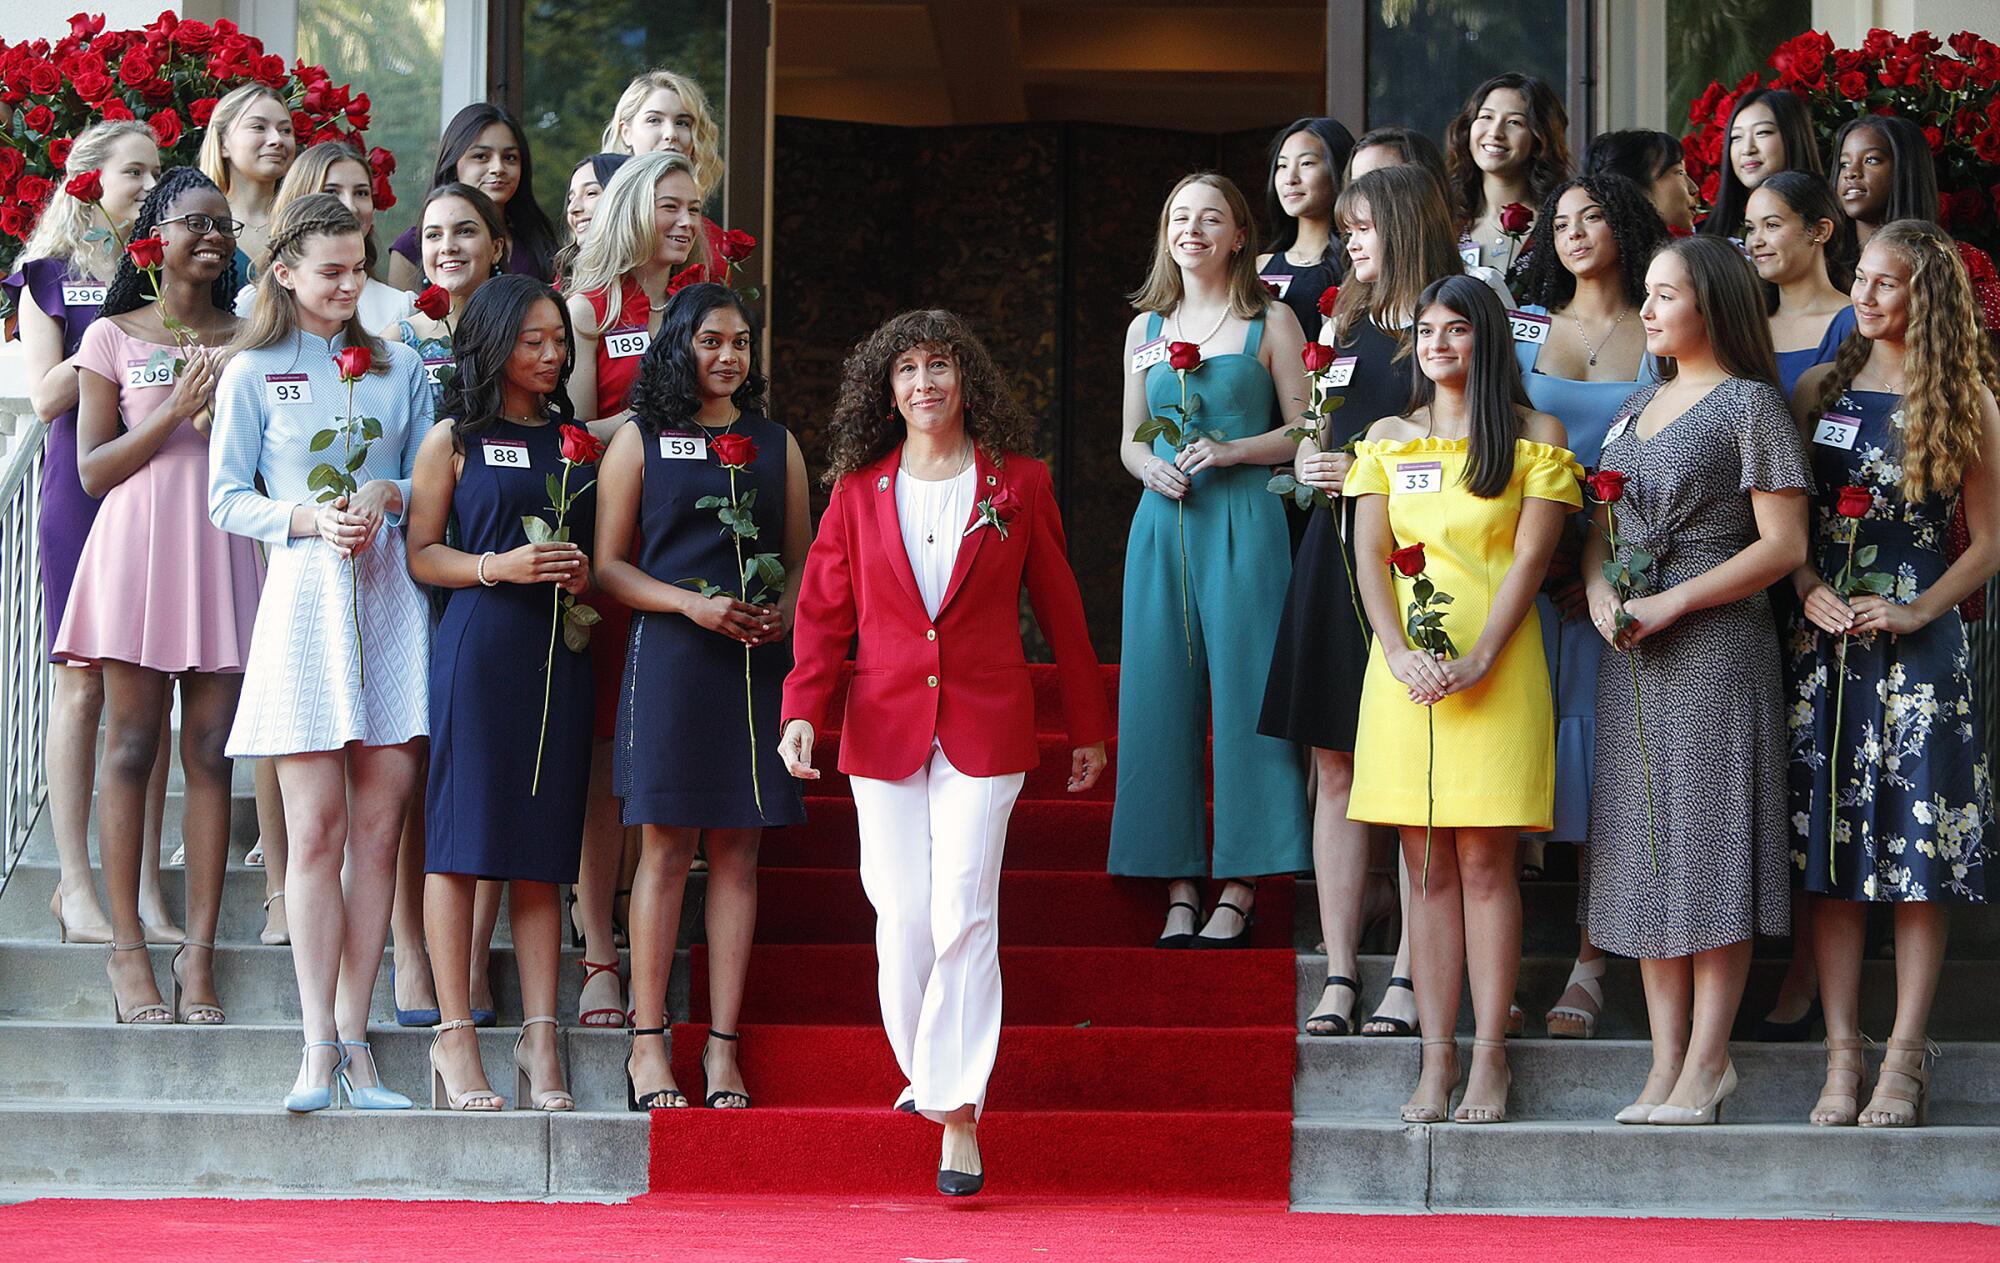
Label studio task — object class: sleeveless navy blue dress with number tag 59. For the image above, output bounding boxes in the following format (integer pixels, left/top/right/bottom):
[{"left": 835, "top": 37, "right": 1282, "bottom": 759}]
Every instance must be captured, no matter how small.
[{"left": 612, "top": 414, "right": 806, "bottom": 829}]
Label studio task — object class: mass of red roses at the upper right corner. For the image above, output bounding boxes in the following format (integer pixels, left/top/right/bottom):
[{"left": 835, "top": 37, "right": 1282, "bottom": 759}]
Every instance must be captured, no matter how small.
[{"left": 1682, "top": 30, "right": 2000, "bottom": 250}]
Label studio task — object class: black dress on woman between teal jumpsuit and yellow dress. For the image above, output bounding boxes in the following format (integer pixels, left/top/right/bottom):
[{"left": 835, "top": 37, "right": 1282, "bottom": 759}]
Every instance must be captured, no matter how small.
[{"left": 1258, "top": 318, "right": 1410, "bottom": 749}]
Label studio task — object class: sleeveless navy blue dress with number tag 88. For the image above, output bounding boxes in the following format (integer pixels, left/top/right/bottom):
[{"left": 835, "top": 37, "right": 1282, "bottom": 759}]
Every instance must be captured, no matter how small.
[{"left": 424, "top": 422, "right": 598, "bottom": 883}]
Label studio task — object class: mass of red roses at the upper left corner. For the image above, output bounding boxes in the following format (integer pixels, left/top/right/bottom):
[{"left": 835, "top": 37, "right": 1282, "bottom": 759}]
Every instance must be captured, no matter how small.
[{"left": 0, "top": 10, "right": 396, "bottom": 274}]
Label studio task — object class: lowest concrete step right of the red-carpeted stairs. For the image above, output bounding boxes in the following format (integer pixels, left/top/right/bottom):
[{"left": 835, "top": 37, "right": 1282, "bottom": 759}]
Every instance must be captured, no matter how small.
[{"left": 1292, "top": 1119, "right": 2000, "bottom": 1219}]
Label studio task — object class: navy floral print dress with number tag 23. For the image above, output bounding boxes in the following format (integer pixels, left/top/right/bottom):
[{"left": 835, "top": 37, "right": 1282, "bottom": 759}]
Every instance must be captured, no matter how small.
[{"left": 1786, "top": 390, "right": 1992, "bottom": 903}]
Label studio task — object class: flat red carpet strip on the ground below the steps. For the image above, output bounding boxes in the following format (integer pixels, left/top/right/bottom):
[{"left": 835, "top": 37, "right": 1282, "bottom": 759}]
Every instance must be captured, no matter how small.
[{"left": 0, "top": 1197, "right": 2000, "bottom": 1263}]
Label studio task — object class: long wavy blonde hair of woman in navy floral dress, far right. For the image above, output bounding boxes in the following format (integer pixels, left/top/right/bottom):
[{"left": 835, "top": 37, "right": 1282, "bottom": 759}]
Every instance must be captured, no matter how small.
[{"left": 1814, "top": 220, "right": 2000, "bottom": 500}]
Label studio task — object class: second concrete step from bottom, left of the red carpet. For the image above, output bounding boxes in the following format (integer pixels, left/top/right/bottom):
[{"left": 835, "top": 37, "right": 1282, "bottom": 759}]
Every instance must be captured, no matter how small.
[{"left": 0, "top": 1013, "right": 672, "bottom": 1111}]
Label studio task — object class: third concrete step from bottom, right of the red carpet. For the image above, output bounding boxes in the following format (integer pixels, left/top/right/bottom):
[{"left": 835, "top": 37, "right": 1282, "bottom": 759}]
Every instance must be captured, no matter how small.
[{"left": 1298, "top": 951, "right": 2000, "bottom": 1047}]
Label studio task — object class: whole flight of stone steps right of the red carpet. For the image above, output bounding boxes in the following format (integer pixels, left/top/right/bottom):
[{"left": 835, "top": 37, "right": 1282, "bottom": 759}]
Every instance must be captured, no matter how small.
[{"left": 1292, "top": 871, "right": 2000, "bottom": 1221}]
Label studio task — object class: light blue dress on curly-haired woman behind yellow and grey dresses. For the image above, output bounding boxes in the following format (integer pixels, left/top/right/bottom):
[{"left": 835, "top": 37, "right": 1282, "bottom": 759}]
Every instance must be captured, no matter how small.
[{"left": 1514, "top": 304, "right": 1652, "bottom": 841}]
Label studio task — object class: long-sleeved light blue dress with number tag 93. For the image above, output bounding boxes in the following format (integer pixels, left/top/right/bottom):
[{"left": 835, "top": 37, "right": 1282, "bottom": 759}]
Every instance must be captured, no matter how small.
[{"left": 208, "top": 332, "right": 432, "bottom": 757}]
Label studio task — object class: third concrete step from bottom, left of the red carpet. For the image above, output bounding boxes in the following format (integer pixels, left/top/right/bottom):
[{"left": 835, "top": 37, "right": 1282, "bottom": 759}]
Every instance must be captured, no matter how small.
[{"left": 0, "top": 941, "right": 688, "bottom": 1027}]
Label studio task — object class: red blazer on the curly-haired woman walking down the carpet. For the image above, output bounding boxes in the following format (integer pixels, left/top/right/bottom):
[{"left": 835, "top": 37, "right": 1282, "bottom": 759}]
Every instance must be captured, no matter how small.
[{"left": 784, "top": 444, "right": 1112, "bottom": 781}]
